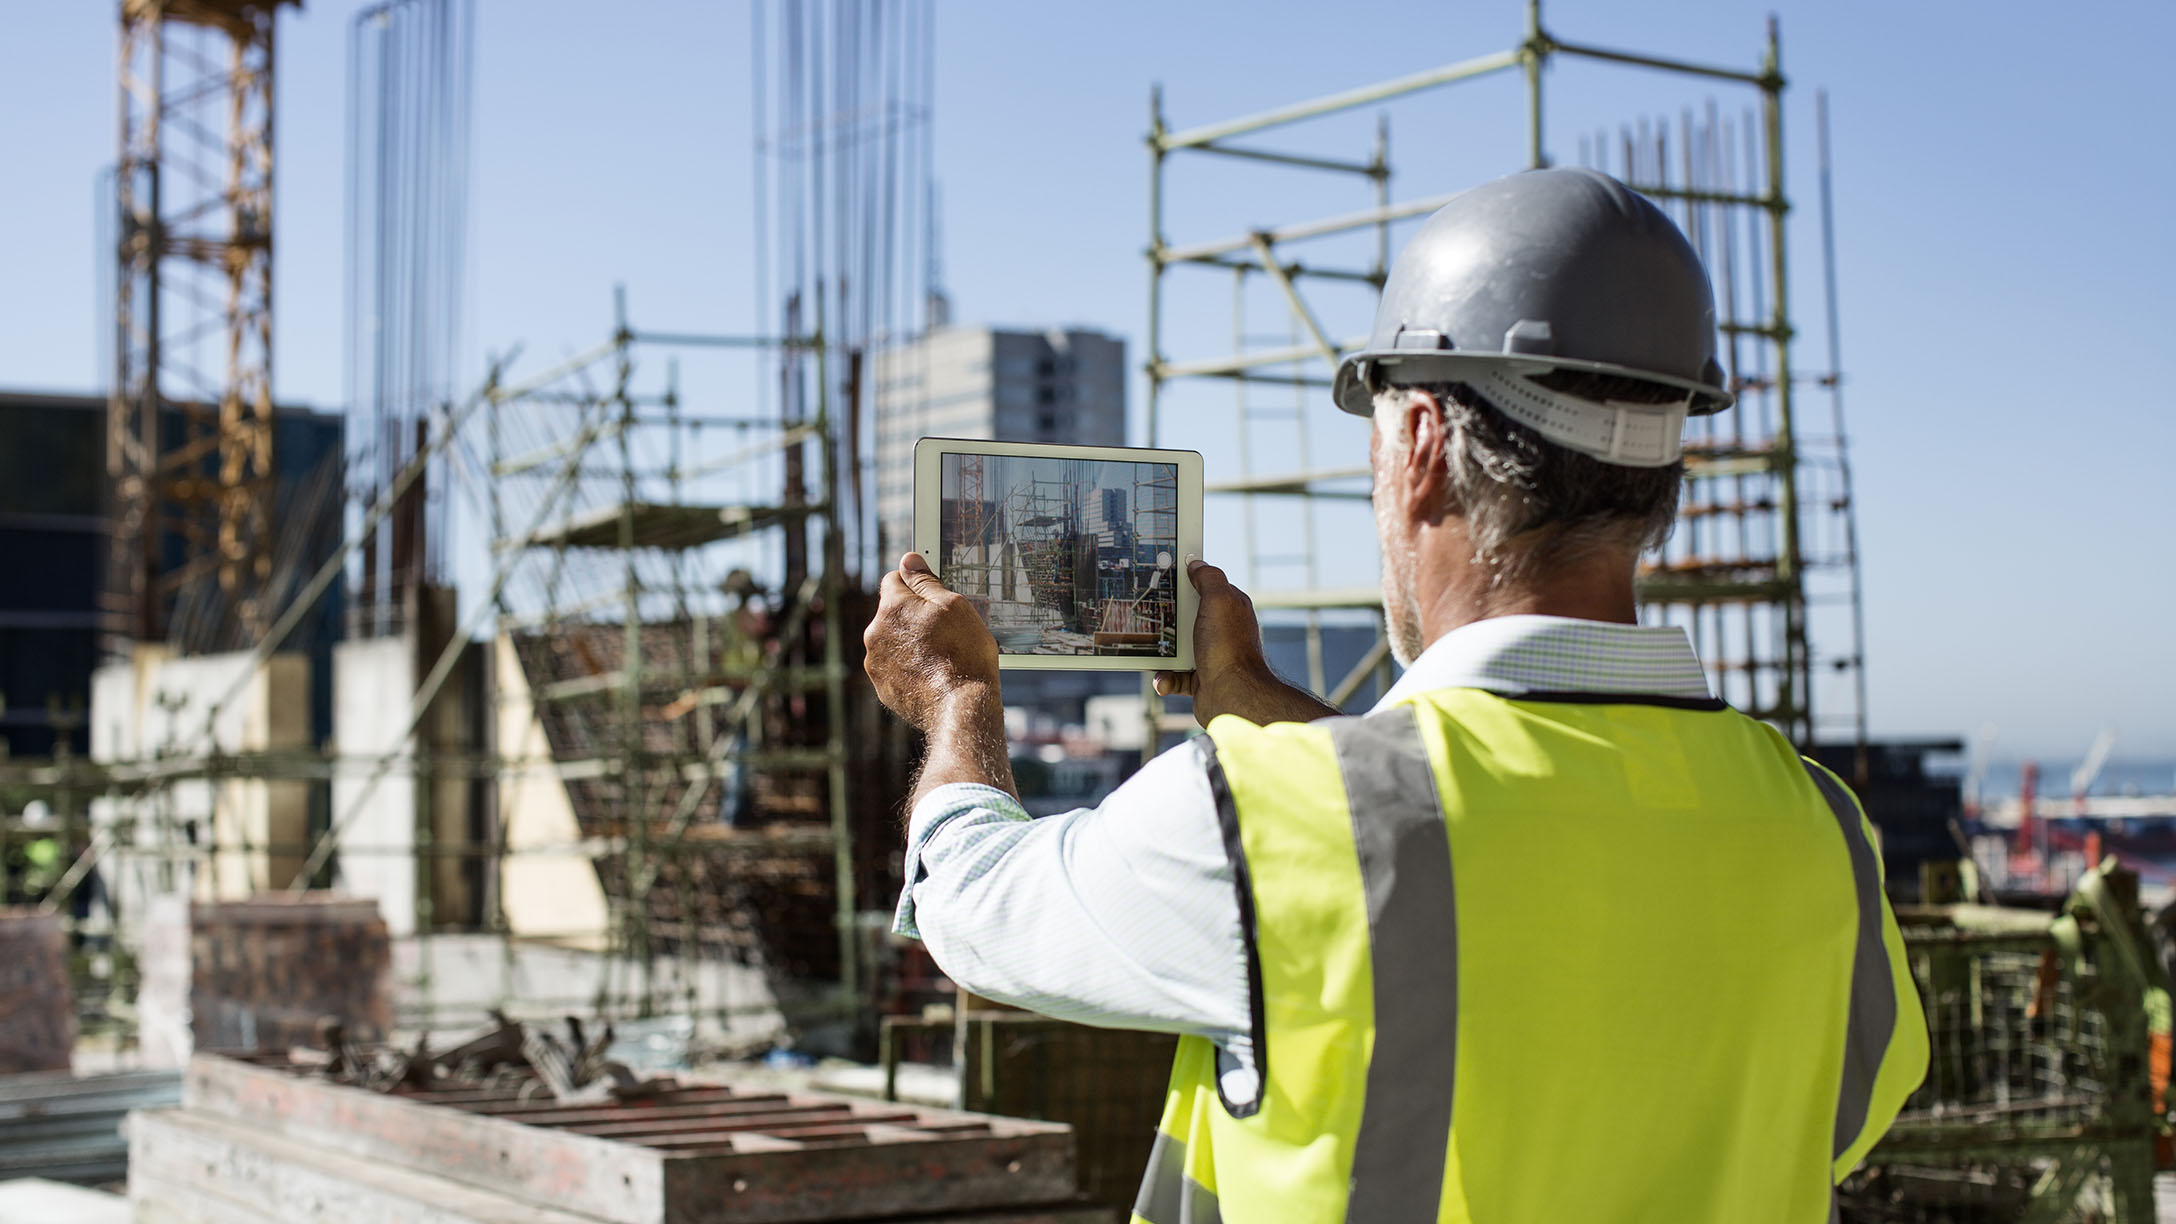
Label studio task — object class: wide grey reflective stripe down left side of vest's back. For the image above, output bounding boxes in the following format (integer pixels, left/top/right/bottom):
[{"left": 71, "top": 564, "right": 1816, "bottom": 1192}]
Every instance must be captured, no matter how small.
[{"left": 1325, "top": 706, "right": 1458, "bottom": 1224}]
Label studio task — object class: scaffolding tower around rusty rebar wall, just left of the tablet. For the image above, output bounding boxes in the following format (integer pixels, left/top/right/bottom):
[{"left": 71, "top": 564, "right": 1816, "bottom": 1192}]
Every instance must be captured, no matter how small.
[{"left": 485, "top": 294, "right": 877, "bottom": 1015}]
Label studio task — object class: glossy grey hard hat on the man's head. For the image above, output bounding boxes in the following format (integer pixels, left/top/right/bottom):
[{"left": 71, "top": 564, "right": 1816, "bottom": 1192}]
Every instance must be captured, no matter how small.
[{"left": 1332, "top": 168, "right": 1732, "bottom": 416}]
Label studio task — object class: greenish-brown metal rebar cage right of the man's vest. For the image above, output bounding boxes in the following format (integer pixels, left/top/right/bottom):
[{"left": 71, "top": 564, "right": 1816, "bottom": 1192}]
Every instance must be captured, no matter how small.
[{"left": 1841, "top": 871, "right": 2167, "bottom": 1224}]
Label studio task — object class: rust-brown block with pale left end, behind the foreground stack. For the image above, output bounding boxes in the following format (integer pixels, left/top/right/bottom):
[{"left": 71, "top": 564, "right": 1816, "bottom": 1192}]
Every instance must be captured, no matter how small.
[{"left": 141, "top": 893, "right": 392, "bottom": 1065}]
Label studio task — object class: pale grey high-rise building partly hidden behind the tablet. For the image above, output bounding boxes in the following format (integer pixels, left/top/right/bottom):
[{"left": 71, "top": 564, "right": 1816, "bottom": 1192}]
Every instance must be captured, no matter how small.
[{"left": 877, "top": 327, "right": 1125, "bottom": 560}]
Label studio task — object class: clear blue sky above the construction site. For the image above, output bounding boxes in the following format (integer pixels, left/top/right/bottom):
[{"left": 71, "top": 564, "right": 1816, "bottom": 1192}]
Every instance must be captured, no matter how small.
[{"left": 0, "top": 0, "right": 2176, "bottom": 756}]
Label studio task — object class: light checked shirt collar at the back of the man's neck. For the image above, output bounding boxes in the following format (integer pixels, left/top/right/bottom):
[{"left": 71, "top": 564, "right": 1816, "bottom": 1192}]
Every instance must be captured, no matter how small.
[{"left": 1375, "top": 616, "right": 1713, "bottom": 710}]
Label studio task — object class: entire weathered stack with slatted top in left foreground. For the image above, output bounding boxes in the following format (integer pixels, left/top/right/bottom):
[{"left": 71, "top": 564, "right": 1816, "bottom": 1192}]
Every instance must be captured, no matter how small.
[{"left": 128, "top": 1054, "right": 1114, "bottom": 1224}]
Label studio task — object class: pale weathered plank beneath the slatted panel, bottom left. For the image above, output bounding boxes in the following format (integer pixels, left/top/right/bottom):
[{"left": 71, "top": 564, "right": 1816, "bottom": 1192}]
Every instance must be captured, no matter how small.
[{"left": 128, "top": 1109, "right": 596, "bottom": 1224}]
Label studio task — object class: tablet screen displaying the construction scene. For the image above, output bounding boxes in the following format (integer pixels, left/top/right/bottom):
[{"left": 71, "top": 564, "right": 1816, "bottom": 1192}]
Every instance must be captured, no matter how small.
[{"left": 938, "top": 455, "right": 1179, "bottom": 658}]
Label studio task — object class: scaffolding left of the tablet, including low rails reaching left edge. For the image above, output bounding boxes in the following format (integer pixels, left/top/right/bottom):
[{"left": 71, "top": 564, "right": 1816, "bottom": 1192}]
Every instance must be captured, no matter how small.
[{"left": 0, "top": 287, "right": 907, "bottom": 1041}]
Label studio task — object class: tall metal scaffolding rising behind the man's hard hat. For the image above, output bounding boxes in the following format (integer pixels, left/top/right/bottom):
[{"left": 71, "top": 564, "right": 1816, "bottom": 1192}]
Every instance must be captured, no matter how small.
[{"left": 1145, "top": 0, "right": 1865, "bottom": 745}]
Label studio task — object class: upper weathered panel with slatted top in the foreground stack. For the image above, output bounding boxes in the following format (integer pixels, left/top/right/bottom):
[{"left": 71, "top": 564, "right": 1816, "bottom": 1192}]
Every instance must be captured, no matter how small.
[{"left": 183, "top": 1054, "right": 1075, "bottom": 1224}]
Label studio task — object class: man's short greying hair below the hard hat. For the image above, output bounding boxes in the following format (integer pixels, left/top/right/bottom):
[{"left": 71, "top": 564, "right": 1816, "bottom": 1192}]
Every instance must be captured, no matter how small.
[{"left": 1375, "top": 370, "right": 1684, "bottom": 586}]
